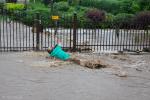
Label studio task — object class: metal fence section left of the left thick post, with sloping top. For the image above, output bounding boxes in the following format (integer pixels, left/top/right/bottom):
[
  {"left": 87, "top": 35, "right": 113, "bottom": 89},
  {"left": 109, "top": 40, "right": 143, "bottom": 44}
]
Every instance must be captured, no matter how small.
[{"left": 0, "top": 10, "right": 36, "bottom": 51}]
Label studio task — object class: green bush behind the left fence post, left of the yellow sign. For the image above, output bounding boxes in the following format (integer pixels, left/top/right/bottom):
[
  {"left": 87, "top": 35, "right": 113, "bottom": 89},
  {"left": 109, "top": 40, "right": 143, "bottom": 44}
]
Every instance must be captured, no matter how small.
[{"left": 9, "top": 10, "right": 50, "bottom": 27}]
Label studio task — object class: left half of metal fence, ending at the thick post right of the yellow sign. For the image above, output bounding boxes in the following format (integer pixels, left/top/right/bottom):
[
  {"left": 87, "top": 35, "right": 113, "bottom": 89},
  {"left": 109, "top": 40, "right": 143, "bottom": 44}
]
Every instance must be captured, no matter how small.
[{"left": 0, "top": 10, "right": 73, "bottom": 51}]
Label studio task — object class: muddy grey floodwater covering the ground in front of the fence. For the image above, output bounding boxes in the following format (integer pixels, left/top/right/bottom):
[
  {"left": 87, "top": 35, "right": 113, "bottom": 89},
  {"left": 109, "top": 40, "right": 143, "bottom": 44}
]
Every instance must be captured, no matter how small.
[{"left": 0, "top": 53, "right": 150, "bottom": 100}]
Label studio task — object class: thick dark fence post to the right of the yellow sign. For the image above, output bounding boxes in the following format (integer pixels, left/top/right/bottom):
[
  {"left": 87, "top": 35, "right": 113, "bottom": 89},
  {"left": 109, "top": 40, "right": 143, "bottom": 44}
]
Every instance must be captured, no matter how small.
[{"left": 73, "top": 13, "right": 77, "bottom": 52}]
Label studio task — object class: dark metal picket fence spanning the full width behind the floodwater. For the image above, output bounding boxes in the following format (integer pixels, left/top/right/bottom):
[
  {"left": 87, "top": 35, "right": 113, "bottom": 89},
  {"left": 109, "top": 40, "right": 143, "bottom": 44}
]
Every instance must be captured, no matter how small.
[{"left": 0, "top": 10, "right": 150, "bottom": 52}]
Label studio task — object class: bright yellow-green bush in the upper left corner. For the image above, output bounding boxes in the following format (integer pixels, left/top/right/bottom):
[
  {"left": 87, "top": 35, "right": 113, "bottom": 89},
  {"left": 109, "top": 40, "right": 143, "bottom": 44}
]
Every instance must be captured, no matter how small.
[{"left": 4, "top": 3, "right": 25, "bottom": 11}]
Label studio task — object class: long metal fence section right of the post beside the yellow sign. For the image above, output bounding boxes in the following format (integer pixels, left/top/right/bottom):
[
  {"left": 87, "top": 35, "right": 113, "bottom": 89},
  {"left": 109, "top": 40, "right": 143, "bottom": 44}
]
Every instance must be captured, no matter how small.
[{"left": 76, "top": 22, "right": 150, "bottom": 52}]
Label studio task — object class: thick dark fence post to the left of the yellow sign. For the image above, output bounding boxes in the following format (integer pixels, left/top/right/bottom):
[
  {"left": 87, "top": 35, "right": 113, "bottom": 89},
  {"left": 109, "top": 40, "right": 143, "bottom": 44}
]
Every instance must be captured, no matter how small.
[{"left": 35, "top": 13, "right": 40, "bottom": 51}]
